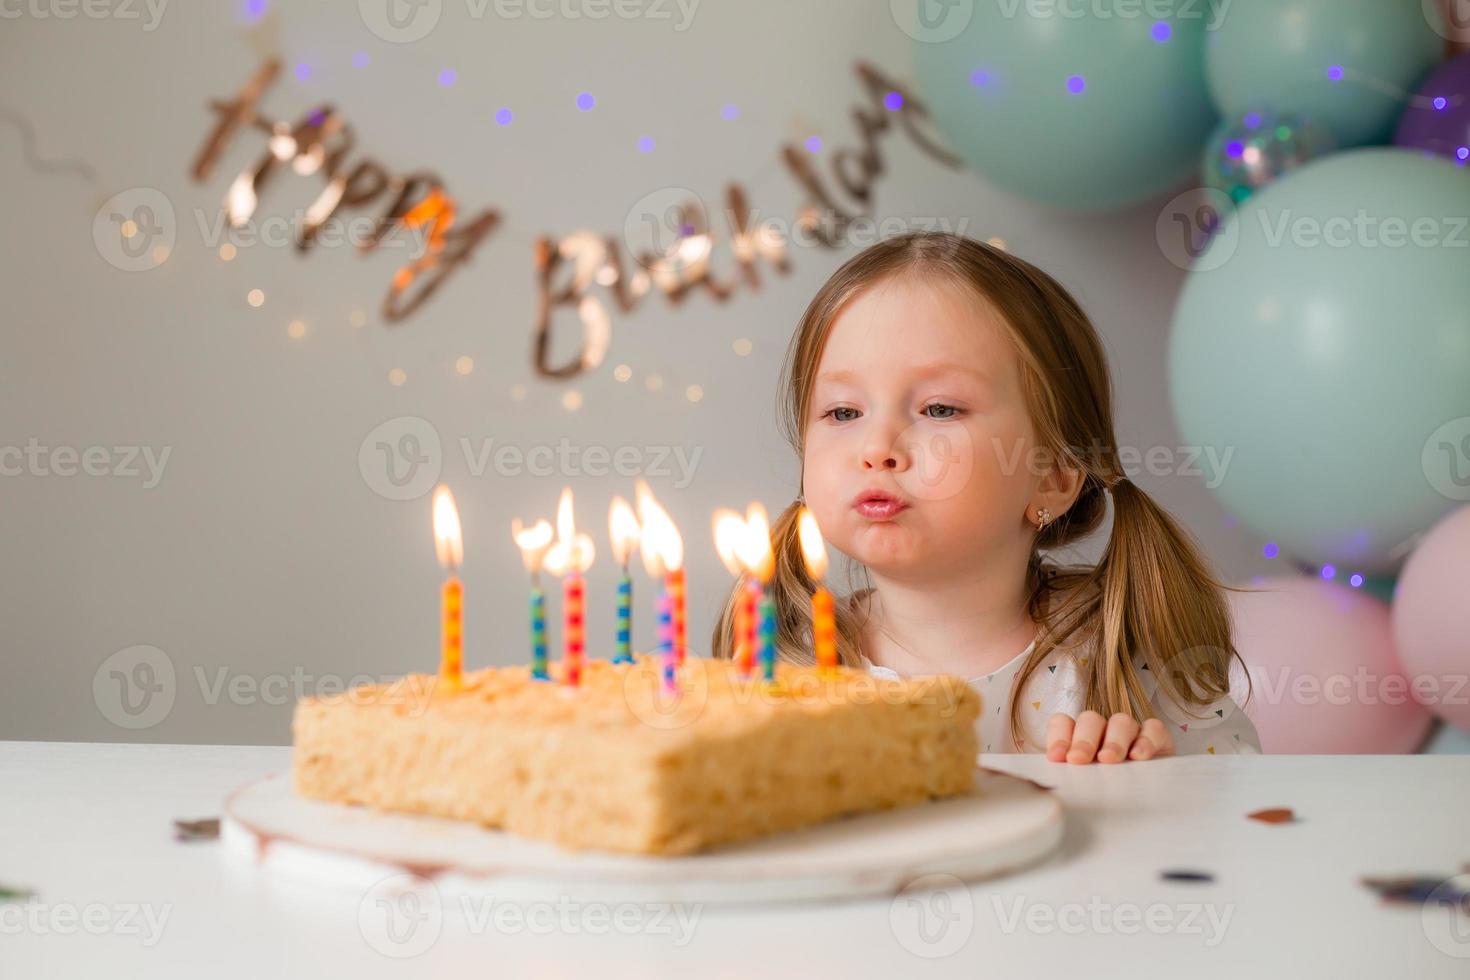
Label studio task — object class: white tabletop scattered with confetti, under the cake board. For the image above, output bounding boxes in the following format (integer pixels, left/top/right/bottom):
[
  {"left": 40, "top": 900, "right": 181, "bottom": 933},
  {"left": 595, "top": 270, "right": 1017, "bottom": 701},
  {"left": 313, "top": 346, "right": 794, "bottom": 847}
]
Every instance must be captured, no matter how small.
[{"left": 0, "top": 742, "right": 1470, "bottom": 980}]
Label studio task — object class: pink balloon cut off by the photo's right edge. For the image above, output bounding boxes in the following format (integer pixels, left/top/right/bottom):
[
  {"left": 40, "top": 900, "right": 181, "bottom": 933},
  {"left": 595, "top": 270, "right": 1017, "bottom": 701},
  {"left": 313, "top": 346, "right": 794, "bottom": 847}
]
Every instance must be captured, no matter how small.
[{"left": 1394, "top": 507, "right": 1470, "bottom": 732}]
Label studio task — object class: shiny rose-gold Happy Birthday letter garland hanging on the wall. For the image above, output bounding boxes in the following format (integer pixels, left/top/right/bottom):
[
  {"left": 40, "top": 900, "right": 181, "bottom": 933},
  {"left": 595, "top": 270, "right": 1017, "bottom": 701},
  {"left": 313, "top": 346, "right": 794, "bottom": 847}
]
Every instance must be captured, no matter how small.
[{"left": 191, "top": 57, "right": 960, "bottom": 379}]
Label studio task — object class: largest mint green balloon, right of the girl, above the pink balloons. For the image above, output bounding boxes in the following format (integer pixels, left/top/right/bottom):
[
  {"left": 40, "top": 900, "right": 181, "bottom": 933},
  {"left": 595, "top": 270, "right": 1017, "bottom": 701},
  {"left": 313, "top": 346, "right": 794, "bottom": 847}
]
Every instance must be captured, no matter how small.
[{"left": 1169, "top": 148, "right": 1470, "bottom": 574}]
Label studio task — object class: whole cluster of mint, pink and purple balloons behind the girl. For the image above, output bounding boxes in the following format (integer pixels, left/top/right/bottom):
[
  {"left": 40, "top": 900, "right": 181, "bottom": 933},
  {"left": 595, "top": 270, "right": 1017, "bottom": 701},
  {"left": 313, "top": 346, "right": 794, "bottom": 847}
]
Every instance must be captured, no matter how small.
[{"left": 908, "top": 0, "right": 1470, "bottom": 752}]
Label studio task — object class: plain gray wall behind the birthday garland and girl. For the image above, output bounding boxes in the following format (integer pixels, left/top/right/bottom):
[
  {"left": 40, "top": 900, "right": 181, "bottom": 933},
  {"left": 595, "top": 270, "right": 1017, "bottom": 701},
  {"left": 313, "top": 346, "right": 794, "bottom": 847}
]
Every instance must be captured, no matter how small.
[{"left": 0, "top": 0, "right": 1272, "bottom": 743}]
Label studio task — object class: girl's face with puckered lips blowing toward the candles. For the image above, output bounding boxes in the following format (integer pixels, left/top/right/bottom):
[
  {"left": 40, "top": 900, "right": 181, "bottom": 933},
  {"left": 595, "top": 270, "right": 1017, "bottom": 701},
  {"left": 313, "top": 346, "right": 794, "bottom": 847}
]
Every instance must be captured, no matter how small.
[{"left": 803, "top": 275, "right": 1039, "bottom": 579}]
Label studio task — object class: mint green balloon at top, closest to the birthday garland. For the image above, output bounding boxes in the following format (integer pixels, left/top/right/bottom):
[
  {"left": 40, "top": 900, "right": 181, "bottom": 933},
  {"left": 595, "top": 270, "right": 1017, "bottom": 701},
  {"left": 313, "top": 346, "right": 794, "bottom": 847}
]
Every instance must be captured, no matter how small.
[{"left": 913, "top": 0, "right": 1216, "bottom": 212}]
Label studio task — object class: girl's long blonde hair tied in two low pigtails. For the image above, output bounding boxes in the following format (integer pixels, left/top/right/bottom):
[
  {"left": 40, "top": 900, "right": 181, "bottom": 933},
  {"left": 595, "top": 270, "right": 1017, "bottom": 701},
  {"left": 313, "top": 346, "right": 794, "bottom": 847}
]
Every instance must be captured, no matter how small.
[{"left": 710, "top": 232, "right": 1248, "bottom": 745}]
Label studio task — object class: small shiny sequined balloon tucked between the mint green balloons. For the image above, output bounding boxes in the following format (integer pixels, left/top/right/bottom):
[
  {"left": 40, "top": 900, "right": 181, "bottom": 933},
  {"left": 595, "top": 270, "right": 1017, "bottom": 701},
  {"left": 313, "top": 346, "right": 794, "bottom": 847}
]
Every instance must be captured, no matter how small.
[{"left": 1204, "top": 112, "right": 1335, "bottom": 204}]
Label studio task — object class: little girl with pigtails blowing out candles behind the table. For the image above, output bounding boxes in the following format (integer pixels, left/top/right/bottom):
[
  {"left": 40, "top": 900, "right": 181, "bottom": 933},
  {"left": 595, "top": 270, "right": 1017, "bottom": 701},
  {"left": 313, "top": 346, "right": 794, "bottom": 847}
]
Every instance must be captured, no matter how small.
[{"left": 711, "top": 234, "right": 1260, "bottom": 763}]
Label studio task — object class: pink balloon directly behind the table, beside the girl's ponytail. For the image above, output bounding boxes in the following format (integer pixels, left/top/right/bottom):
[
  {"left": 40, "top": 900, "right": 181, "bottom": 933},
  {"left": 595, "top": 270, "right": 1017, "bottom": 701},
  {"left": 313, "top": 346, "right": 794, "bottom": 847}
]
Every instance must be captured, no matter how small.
[{"left": 1230, "top": 577, "right": 1433, "bottom": 754}]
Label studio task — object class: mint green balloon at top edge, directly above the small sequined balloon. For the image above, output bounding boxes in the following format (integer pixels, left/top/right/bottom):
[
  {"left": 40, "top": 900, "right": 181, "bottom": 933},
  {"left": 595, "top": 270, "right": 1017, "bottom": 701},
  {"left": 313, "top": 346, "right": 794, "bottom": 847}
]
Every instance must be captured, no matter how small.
[{"left": 1205, "top": 0, "right": 1445, "bottom": 147}]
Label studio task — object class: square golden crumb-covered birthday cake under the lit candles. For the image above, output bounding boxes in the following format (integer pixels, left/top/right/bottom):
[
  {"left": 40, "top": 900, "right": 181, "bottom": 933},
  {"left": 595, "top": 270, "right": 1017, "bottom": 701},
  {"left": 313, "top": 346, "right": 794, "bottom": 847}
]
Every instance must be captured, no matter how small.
[{"left": 293, "top": 654, "right": 980, "bottom": 855}]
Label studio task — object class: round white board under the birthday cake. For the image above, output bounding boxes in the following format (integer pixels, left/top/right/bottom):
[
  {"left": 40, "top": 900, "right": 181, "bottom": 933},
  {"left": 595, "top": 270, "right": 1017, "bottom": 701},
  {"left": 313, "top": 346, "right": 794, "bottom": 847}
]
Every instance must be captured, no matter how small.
[{"left": 221, "top": 768, "right": 1063, "bottom": 904}]
